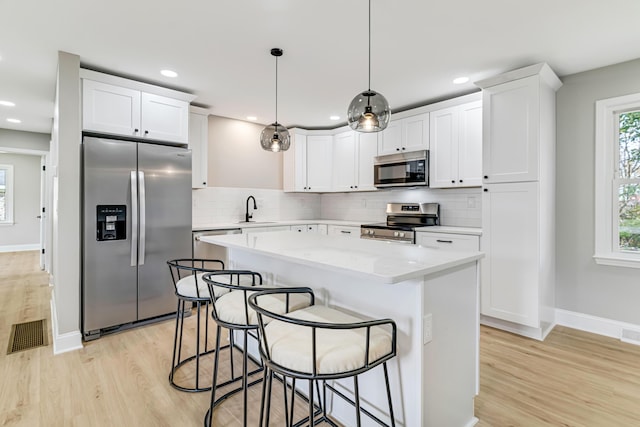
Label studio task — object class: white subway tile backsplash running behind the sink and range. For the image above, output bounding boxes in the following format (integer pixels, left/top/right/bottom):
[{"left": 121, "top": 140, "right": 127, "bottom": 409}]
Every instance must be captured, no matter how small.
[{"left": 192, "top": 187, "right": 482, "bottom": 227}]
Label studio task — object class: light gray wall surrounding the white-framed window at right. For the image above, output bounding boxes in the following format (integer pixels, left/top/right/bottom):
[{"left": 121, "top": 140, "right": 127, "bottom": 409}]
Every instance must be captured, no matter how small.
[{"left": 556, "top": 60, "right": 640, "bottom": 324}]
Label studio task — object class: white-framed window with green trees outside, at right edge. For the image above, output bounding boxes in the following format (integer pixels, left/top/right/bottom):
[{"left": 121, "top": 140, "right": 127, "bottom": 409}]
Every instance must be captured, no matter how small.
[{"left": 594, "top": 94, "right": 640, "bottom": 268}]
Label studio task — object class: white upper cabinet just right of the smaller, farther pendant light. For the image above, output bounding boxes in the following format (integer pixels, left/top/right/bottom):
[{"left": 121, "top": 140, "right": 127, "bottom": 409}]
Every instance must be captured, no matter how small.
[{"left": 283, "top": 129, "right": 333, "bottom": 193}]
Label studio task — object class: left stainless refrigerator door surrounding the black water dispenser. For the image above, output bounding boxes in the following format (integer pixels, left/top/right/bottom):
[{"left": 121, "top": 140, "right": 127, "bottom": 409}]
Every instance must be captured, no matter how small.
[{"left": 82, "top": 137, "right": 139, "bottom": 335}]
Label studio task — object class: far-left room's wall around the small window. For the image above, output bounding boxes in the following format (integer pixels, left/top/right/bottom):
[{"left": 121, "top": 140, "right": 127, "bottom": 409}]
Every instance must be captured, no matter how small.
[{"left": 0, "top": 153, "right": 40, "bottom": 249}]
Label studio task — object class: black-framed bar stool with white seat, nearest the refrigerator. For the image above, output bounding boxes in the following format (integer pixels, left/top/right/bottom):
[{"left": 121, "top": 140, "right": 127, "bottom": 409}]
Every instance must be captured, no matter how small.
[{"left": 167, "top": 258, "right": 230, "bottom": 392}]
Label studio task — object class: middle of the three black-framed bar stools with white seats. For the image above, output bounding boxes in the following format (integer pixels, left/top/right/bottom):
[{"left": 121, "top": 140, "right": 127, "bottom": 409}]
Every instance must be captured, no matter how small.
[{"left": 202, "top": 270, "right": 305, "bottom": 427}]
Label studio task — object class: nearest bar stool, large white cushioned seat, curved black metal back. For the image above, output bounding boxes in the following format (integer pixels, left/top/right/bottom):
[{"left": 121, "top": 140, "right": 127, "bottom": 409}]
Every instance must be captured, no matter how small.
[{"left": 248, "top": 288, "right": 396, "bottom": 426}]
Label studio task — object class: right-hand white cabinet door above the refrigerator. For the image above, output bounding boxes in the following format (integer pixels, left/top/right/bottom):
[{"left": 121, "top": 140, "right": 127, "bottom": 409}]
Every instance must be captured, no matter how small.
[{"left": 141, "top": 92, "right": 189, "bottom": 144}]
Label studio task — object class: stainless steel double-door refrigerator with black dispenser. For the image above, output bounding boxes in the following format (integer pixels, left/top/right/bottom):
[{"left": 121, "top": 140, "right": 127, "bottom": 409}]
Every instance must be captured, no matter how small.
[{"left": 81, "top": 136, "right": 191, "bottom": 340}]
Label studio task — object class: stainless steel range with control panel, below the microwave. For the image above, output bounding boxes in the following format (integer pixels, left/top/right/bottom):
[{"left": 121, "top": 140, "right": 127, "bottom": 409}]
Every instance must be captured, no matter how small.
[{"left": 360, "top": 203, "right": 440, "bottom": 244}]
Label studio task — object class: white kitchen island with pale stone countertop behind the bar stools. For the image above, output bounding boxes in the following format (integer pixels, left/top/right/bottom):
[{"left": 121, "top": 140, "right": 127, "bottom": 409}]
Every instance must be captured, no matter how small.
[{"left": 202, "top": 231, "right": 483, "bottom": 427}]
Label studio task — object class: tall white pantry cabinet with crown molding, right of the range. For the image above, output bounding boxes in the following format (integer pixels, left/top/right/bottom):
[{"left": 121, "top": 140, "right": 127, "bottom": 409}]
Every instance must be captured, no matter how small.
[{"left": 476, "top": 63, "right": 562, "bottom": 340}]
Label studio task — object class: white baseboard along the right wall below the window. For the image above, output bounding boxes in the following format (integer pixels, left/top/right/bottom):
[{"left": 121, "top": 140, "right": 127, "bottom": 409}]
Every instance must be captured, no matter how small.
[{"left": 556, "top": 308, "right": 640, "bottom": 345}]
